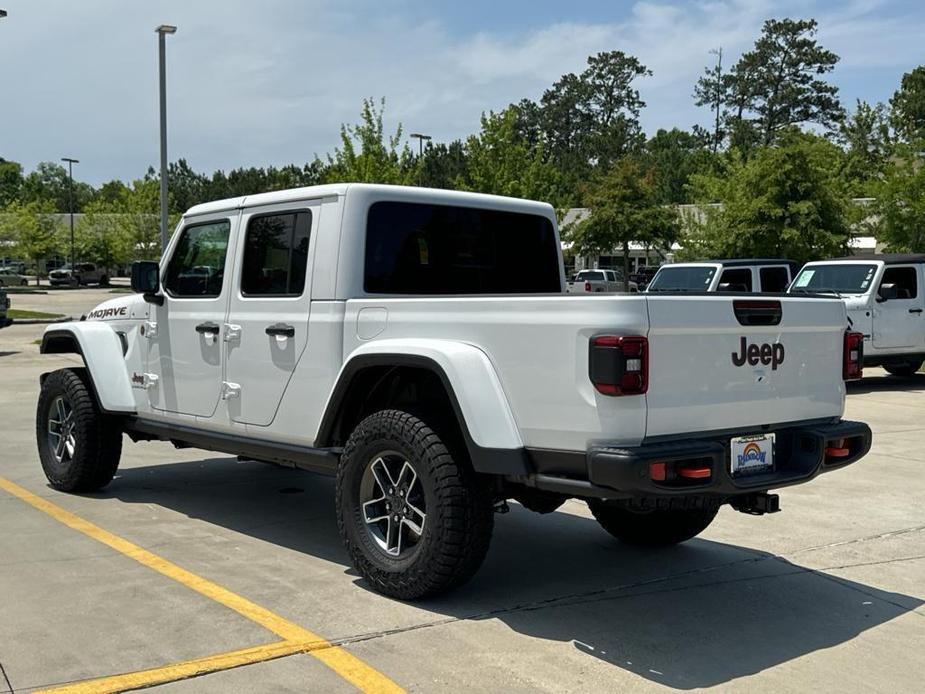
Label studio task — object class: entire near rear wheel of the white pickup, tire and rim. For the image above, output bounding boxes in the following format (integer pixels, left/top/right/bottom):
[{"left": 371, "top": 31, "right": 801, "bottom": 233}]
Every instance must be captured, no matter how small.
[{"left": 336, "top": 410, "right": 494, "bottom": 600}]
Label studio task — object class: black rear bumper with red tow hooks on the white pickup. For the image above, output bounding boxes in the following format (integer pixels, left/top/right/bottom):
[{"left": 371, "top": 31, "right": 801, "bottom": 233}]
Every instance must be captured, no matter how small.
[{"left": 523, "top": 421, "right": 871, "bottom": 499}]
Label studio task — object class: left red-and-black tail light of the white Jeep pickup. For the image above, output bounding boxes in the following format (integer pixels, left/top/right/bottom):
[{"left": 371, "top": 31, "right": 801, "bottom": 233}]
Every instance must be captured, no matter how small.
[{"left": 588, "top": 335, "right": 649, "bottom": 395}]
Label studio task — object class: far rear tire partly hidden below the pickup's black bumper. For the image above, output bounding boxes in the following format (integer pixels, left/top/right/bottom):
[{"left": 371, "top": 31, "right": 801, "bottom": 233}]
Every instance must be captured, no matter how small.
[{"left": 588, "top": 498, "right": 719, "bottom": 547}]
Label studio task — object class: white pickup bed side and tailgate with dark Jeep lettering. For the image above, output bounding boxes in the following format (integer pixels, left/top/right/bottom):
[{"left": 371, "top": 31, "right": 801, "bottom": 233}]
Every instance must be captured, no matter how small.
[{"left": 343, "top": 294, "right": 847, "bottom": 451}]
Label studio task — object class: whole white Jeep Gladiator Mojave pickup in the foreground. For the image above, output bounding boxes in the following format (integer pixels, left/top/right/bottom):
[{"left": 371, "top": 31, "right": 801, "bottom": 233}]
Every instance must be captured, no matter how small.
[{"left": 36, "top": 184, "right": 871, "bottom": 599}]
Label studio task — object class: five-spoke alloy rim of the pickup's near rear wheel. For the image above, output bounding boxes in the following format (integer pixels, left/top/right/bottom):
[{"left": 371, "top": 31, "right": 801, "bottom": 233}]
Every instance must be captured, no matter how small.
[{"left": 360, "top": 451, "right": 427, "bottom": 558}]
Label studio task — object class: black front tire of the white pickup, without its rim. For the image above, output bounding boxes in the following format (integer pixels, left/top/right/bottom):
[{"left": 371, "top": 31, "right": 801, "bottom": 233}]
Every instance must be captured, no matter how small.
[{"left": 35, "top": 369, "right": 122, "bottom": 492}]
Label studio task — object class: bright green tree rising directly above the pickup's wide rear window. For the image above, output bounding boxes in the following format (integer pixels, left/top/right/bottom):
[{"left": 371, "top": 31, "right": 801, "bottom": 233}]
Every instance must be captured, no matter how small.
[{"left": 458, "top": 107, "right": 562, "bottom": 205}]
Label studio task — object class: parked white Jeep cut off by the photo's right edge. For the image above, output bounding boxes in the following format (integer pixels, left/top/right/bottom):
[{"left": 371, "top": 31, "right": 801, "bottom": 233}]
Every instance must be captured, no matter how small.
[{"left": 790, "top": 253, "right": 925, "bottom": 377}]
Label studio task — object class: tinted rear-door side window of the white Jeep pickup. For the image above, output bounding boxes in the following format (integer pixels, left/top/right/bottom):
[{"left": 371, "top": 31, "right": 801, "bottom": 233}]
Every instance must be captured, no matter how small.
[{"left": 241, "top": 211, "right": 312, "bottom": 296}]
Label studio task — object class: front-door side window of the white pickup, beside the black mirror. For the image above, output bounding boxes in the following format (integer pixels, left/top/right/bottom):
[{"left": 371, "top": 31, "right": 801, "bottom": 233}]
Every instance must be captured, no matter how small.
[{"left": 164, "top": 219, "right": 231, "bottom": 297}]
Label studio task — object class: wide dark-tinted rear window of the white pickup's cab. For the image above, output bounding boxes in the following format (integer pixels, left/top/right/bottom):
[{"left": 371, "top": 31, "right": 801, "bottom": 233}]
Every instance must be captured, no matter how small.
[{"left": 363, "top": 202, "right": 562, "bottom": 294}]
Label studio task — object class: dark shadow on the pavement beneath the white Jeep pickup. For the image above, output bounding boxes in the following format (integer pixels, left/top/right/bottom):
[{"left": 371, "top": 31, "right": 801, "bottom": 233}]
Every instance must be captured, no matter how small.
[{"left": 103, "top": 458, "right": 923, "bottom": 689}]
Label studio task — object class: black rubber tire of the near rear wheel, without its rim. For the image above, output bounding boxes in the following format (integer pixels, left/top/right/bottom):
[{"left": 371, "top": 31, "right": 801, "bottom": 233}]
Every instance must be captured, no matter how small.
[{"left": 336, "top": 410, "right": 494, "bottom": 600}]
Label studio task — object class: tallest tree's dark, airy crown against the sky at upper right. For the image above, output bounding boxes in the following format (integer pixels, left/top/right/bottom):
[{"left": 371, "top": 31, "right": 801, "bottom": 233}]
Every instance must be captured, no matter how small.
[{"left": 694, "top": 19, "right": 843, "bottom": 150}]
